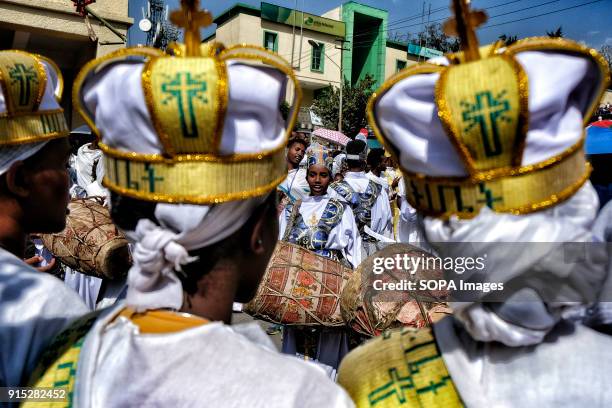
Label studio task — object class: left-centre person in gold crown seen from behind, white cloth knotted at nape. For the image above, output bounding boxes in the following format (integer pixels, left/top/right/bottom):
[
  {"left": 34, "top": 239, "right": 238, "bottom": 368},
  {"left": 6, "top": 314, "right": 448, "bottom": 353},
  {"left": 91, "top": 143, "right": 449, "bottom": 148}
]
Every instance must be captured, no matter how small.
[{"left": 26, "top": 0, "right": 353, "bottom": 407}]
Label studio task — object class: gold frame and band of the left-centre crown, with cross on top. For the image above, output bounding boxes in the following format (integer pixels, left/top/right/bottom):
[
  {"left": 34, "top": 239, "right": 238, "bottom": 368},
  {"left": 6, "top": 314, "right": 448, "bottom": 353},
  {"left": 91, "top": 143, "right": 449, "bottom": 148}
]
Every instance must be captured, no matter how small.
[{"left": 73, "top": 0, "right": 301, "bottom": 204}]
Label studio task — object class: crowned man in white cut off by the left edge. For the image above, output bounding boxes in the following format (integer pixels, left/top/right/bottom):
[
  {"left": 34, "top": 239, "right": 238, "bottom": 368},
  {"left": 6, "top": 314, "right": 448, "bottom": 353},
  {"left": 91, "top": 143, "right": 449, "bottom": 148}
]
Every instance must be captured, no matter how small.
[{"left": 0, "top": 50, "right": 87, "bottom": 387}]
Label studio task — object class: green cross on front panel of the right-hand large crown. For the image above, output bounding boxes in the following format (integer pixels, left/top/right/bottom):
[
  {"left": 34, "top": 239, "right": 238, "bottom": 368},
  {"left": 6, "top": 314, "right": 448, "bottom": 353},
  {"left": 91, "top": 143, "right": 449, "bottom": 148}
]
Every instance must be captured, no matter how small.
[{"left": 461, "top": 91, "right": 512, "bottom": 157}]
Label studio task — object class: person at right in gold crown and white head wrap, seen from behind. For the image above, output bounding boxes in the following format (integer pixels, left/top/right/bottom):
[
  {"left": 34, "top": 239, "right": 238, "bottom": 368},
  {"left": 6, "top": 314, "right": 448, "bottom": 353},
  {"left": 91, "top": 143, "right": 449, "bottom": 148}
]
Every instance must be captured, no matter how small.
[{"left": 339, "top": 0, "right": 612, "bottom": 407}]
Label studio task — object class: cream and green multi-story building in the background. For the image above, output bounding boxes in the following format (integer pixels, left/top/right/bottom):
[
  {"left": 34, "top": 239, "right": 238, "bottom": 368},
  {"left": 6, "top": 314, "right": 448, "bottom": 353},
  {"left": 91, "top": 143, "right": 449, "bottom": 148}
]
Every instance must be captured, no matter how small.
[{"left": 204, "top": 1, "right": 441, "bottom": 117}]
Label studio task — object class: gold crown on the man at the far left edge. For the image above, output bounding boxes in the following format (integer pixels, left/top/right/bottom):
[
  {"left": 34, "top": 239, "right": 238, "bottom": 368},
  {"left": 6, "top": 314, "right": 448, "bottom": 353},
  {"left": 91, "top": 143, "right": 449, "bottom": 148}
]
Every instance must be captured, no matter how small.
[{"left": 0, "top": 50, "right": 69, "bottom": 146}]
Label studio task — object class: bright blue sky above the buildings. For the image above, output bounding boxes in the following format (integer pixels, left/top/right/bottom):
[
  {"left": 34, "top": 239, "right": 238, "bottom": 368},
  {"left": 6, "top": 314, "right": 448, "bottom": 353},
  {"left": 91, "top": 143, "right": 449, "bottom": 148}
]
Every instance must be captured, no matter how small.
[{"left": 130, "top": 0, "right": 612, "bottom": 48}]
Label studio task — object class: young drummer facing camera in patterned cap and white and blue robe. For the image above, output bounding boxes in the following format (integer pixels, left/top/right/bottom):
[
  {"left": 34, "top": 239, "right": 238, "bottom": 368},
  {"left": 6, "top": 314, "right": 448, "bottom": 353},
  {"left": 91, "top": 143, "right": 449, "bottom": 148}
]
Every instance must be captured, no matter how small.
[{"left": 279, "top": 145, "right": 361, "bottom": 370}]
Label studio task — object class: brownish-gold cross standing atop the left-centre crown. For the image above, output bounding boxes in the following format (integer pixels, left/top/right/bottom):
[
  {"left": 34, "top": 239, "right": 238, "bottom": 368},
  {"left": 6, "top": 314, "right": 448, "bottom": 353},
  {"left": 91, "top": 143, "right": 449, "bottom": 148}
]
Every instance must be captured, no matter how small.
[{"left": 170, "top": 0, "right": 213, "bottom": 57}]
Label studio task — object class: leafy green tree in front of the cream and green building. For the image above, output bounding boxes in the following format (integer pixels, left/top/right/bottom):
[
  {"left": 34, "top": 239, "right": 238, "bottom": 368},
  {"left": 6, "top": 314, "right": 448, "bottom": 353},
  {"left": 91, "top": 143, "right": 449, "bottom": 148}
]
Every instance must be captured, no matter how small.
[{"left": 312, "top": 75, "right": 375, "bottom": 137}]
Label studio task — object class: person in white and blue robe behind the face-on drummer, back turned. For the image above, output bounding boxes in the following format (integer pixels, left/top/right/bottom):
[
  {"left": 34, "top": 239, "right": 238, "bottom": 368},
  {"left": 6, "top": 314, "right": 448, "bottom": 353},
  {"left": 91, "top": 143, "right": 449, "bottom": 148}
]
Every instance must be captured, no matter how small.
[{"left": 330, "top": 140, "right": 393, "bottom": 256}]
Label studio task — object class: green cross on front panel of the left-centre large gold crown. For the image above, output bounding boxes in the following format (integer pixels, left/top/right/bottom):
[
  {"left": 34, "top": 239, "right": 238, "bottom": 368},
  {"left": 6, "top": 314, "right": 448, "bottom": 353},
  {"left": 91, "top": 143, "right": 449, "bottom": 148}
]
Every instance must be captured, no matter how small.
[{"left": 161, "top": 72, "right": 208, "bottom": 138}]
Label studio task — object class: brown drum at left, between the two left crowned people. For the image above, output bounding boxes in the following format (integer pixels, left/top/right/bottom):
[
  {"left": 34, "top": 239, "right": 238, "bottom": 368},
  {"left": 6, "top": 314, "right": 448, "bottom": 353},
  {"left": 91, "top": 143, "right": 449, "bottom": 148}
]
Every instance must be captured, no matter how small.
[{"left": 40, "top": 197, "right": 131, "bottom": 280}]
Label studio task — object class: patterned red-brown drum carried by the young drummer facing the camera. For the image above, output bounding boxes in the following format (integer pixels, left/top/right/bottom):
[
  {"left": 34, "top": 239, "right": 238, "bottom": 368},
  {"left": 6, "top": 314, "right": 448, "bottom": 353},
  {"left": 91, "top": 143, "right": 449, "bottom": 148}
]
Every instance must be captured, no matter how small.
[{"left": 243, "top": 241, "right": 353, "bottom": 327}]
